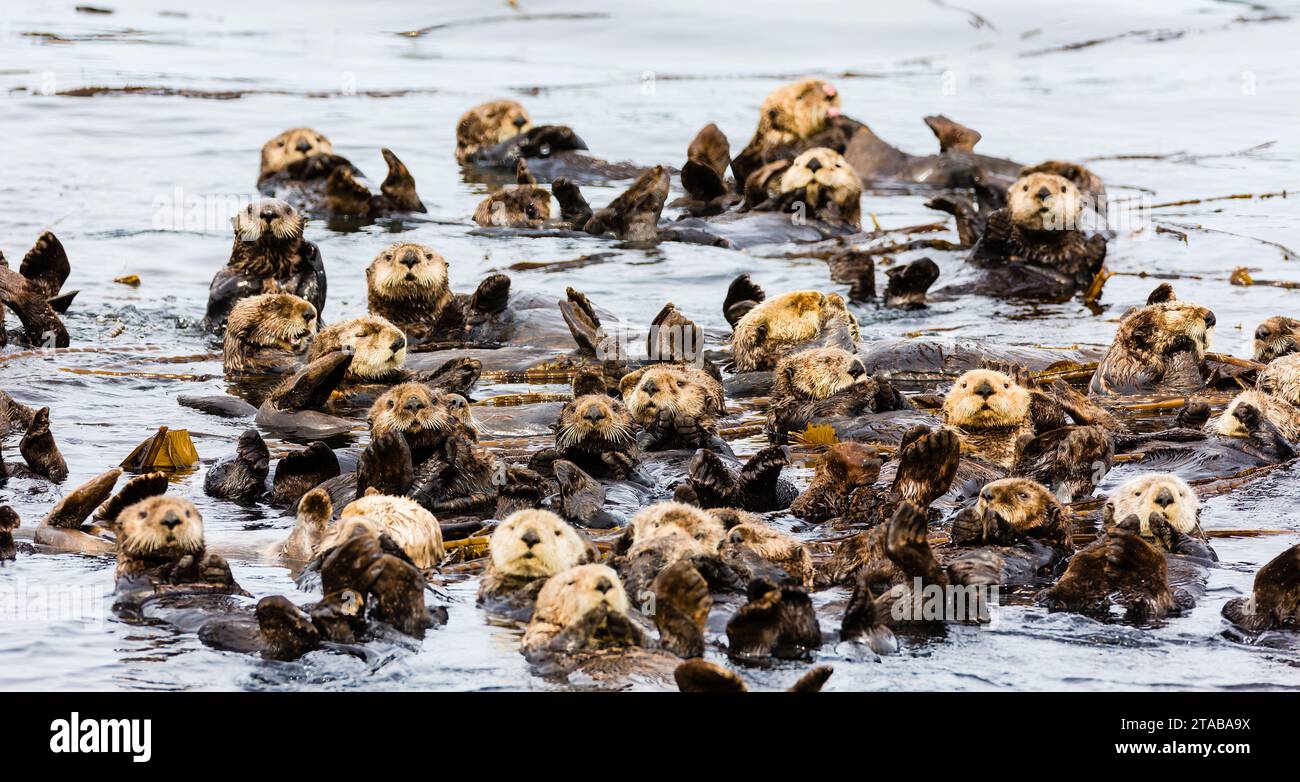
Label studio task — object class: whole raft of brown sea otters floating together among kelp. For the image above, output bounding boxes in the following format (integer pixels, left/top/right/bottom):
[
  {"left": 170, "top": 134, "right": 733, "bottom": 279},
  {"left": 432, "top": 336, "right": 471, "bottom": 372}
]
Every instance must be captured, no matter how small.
[{"left": 0, "top": 79, "right": 1300, "bottom": 691}]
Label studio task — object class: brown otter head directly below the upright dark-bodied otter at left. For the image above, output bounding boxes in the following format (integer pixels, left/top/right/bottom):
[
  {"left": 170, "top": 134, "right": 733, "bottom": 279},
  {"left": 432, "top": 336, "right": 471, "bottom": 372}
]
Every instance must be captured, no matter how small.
[{"left": 221, "top": 294, "right": 319, "bottom": 377}]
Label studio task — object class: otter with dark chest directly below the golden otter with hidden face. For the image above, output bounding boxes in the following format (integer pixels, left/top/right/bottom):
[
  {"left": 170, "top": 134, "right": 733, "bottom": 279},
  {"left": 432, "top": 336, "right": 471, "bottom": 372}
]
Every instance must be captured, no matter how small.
[{"left": 767, "top": 347, "right": 911, "bottom": 443}]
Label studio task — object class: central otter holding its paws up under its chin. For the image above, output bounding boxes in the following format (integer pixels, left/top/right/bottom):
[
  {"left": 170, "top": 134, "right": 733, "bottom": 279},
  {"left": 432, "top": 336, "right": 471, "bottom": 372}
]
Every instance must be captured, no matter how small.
[{"left": 619, "top": 364, "right": 731, "bottom": 453}]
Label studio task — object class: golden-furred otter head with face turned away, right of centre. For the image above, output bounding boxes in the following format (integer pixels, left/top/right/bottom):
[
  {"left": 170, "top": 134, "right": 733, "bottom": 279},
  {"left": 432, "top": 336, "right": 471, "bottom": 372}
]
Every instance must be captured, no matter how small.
[{"left": 732, "top": 291, "right": 858, "bottom": 372}]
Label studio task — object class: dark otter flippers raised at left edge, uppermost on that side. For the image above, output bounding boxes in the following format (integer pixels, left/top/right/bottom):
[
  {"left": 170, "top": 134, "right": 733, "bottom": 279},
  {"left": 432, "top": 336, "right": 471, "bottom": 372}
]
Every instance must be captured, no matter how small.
[{"left": 0, "top": 231, "right": 77, "bottom": 348}]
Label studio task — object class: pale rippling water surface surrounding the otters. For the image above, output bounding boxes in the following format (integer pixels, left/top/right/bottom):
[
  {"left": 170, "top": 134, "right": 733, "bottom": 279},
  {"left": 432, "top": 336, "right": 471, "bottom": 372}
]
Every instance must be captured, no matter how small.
[{"left": 0, "top": 0, "right": 1300, "bottom": 690}]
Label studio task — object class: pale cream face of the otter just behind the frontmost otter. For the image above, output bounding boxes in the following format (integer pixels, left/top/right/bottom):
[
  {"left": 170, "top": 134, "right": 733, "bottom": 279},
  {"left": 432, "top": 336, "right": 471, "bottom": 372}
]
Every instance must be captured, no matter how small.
[{"left": 488, "top": 509, "right": 586, "bottom": 578}]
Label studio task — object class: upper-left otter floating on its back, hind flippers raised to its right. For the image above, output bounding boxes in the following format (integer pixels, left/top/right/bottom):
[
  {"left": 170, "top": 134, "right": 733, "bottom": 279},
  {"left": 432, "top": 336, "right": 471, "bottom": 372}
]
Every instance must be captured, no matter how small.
[{"left": 257, "top": 127, "right": 426, "bottom": 220}]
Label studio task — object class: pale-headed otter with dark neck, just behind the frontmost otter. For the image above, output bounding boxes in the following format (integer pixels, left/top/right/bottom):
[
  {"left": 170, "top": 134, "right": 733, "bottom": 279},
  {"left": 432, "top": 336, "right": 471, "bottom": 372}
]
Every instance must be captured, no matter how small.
[{"left": 478, "top": 511, "right": 594, "bottom": 620}]
